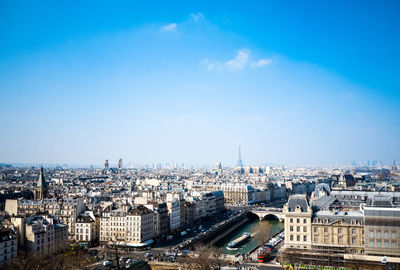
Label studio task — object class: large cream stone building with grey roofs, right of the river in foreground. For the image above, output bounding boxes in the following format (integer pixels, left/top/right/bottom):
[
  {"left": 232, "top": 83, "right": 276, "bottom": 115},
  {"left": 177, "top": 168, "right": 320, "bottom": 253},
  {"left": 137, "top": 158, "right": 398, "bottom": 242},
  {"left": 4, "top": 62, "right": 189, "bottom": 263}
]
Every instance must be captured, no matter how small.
[{"left": 283, "top": 193, "right": 400, "bottom": 269}]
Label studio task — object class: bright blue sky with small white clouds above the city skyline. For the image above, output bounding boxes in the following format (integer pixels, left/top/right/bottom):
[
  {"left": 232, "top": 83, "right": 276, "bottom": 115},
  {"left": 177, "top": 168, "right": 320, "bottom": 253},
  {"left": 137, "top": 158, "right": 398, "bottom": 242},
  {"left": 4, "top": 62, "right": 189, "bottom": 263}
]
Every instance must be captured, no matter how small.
[{"left": 0, "top": 1, "right": 400, "bottom": 165}]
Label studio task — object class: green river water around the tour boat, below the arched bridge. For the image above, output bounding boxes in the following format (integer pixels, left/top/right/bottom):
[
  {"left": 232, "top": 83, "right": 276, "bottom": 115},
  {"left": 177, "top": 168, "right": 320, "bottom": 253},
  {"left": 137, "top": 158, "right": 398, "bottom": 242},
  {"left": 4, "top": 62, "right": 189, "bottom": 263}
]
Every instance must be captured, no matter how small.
[{"left": 216, "top": 219, "right": 283, "bottom": 255}]
